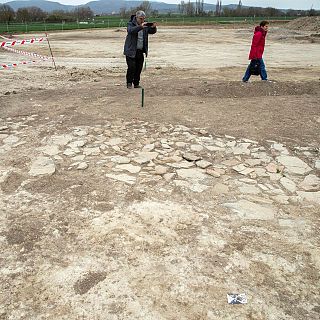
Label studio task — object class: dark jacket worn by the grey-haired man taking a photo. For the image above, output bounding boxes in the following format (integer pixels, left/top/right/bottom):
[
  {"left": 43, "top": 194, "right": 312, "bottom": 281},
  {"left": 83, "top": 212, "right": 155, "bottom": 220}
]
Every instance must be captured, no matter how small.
[{"left": 123, "top": 15, "right": 157, "bottom": 58}]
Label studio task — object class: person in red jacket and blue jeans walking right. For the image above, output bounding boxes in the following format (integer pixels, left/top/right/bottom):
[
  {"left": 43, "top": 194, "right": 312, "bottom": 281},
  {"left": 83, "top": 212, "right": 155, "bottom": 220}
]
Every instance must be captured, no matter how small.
[{"left": 242, "top": 20, "right": 269, "bottom": 82}]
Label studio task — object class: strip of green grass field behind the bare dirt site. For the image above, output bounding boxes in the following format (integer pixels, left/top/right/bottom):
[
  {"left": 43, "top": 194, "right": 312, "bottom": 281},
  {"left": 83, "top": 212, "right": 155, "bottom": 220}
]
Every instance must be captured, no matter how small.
[{"left": 0, "top": 16, "right": 294, "bottom": 33}]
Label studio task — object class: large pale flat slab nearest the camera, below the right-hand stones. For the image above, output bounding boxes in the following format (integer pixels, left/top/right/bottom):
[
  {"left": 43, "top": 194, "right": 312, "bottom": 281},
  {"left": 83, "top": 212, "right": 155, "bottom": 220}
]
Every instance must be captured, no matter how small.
[{"left": 224, "top": 200, "right": 277, "bottom": 220}]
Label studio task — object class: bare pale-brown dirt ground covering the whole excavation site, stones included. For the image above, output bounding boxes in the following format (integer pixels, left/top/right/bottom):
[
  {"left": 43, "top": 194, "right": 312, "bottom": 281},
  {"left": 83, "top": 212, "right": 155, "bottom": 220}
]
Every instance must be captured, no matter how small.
[{"left": 0, "top": 26, "right": 320, "bottom": 320}]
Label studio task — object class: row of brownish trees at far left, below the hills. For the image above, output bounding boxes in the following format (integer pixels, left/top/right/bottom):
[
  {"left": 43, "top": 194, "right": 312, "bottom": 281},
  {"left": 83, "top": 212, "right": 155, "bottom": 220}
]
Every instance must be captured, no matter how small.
[{"left": 0, "top": 4, "right": 94, "bottom": 23}]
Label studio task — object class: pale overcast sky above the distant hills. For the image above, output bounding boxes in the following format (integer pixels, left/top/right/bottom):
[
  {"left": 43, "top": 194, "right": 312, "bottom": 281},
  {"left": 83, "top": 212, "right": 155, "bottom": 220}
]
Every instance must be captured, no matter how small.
[{"left": 0, "top": 0, "right": 320, "bottom": 10}]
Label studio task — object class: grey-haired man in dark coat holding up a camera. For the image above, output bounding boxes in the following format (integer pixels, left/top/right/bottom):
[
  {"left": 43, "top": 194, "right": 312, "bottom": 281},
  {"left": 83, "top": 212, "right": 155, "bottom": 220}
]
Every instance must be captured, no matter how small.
[{"left": 124, "top": 10, "right": 157, "bottom": 89}]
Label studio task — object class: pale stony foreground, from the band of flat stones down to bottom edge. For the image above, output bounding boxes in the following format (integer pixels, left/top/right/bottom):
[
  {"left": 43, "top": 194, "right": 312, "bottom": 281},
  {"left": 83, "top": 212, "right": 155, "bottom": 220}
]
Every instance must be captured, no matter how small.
[{"left": 0, "top": 115, "right": 320, "bottom": 319}]
